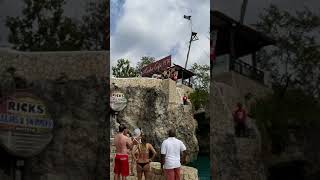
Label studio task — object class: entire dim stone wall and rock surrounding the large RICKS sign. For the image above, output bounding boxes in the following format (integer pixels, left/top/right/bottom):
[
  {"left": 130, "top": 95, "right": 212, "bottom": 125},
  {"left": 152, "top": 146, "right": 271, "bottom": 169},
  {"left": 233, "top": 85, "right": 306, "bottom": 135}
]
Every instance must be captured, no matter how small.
[{"left": 0, "top": 49, "right": 110, "bottom": 180}]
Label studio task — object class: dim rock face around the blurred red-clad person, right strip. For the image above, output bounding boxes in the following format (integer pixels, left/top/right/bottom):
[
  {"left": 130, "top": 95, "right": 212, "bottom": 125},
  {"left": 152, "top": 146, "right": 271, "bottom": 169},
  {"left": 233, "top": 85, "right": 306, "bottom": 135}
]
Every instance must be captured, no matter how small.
[{"left": 210, "top": 83, "right": 266, "bottom": 180}]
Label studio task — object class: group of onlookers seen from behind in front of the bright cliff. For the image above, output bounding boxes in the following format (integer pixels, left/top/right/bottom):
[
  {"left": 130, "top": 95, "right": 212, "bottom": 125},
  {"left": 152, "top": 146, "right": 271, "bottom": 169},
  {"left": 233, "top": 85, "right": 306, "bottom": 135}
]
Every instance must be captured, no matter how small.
[{"left": 114, "top": 124, "right": 186, "bottom": 180}]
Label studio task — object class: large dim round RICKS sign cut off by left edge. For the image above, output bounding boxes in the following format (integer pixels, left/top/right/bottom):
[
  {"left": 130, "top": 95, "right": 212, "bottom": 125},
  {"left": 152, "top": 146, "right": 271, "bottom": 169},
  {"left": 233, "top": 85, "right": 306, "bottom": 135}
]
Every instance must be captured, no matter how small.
[{"left": 0, "top": 92, "right": 53, "bottom": 157}]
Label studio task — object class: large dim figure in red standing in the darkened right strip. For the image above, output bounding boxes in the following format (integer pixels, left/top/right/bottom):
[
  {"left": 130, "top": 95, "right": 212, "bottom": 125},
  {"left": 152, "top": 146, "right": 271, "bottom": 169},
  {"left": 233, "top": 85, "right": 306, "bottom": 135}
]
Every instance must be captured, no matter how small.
[{"left": 233, "top": 103, "right": 247, "bottom": 137}]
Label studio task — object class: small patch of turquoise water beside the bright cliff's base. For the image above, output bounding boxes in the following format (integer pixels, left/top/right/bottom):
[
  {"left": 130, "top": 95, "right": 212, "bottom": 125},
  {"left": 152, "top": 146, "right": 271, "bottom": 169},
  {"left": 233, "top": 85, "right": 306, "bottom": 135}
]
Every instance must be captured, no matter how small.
[{"left": 188, "top": 155, "right": 211, "bottom": 180}]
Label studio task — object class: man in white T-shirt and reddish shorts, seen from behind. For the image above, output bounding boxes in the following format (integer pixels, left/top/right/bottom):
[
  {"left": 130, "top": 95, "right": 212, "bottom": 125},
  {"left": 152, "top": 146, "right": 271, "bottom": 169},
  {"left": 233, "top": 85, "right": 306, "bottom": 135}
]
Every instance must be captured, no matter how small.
[{"left": 161, "top": 129, "right": 186, "bottom": 180}]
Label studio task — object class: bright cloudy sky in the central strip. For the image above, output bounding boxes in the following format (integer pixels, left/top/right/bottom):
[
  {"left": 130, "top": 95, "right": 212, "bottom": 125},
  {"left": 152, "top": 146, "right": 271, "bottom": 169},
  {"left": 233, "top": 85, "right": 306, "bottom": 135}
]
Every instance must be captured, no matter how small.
[{"left": 110, "top": 0, "right": 210, "bottom": 68}]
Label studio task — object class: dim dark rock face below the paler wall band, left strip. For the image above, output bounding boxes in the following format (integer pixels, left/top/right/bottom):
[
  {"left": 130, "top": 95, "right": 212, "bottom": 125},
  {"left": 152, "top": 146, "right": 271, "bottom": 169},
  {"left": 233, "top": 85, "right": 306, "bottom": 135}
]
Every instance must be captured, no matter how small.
[{"left": 0, "top": 78, "right": 110, "bottom": 180}]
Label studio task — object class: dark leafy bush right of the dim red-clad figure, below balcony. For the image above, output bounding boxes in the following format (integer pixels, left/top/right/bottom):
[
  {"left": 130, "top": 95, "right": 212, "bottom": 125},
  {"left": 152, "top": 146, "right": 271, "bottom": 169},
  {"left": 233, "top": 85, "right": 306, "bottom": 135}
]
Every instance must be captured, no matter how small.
[{"left": 251, "top": 89, "right": 320, "bottom": 153}]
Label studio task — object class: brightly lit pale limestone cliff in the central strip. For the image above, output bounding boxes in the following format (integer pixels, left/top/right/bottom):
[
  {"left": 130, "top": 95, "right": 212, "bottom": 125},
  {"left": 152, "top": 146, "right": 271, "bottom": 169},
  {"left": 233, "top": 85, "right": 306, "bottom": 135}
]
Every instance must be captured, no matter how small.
[{"left": 111, "top": 78, "right": 199, "bottom": 158}]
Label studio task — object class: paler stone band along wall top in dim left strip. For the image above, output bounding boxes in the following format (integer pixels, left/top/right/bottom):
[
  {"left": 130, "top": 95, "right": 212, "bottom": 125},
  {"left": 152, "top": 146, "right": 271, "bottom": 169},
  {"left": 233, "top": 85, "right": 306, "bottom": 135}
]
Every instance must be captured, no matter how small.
[{"left": 0, "top": 48, "right": 109, "bottom": 80}]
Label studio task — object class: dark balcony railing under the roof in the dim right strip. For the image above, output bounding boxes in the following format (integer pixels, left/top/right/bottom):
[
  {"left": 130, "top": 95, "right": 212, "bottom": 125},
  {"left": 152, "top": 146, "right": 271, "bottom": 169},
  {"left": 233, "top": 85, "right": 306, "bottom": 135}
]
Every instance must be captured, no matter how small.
[{"left": 230, "top": 59, "right": 264, "bottom": 84}]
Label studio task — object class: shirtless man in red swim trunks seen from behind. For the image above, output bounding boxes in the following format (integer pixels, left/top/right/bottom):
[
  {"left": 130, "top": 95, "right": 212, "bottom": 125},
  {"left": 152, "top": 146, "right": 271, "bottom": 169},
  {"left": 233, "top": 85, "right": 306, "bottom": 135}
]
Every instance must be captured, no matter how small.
[{"left": 114, "top": 124, "right": 136, "bottom": 180}]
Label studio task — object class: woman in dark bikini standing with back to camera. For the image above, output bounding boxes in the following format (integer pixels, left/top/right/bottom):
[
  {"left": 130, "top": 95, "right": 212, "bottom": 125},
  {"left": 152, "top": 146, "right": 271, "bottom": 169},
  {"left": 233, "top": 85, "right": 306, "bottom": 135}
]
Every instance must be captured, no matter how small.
[{"left": 133, "top": 134, "right": 156, "bottom": 180}]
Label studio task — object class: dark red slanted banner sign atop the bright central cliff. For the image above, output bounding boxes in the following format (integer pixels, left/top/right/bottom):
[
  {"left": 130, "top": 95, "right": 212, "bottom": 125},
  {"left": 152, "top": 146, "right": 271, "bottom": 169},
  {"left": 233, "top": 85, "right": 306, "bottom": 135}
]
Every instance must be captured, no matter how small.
[{"left": 142, "top": 55, "right": 171, "bottom": 77}]
